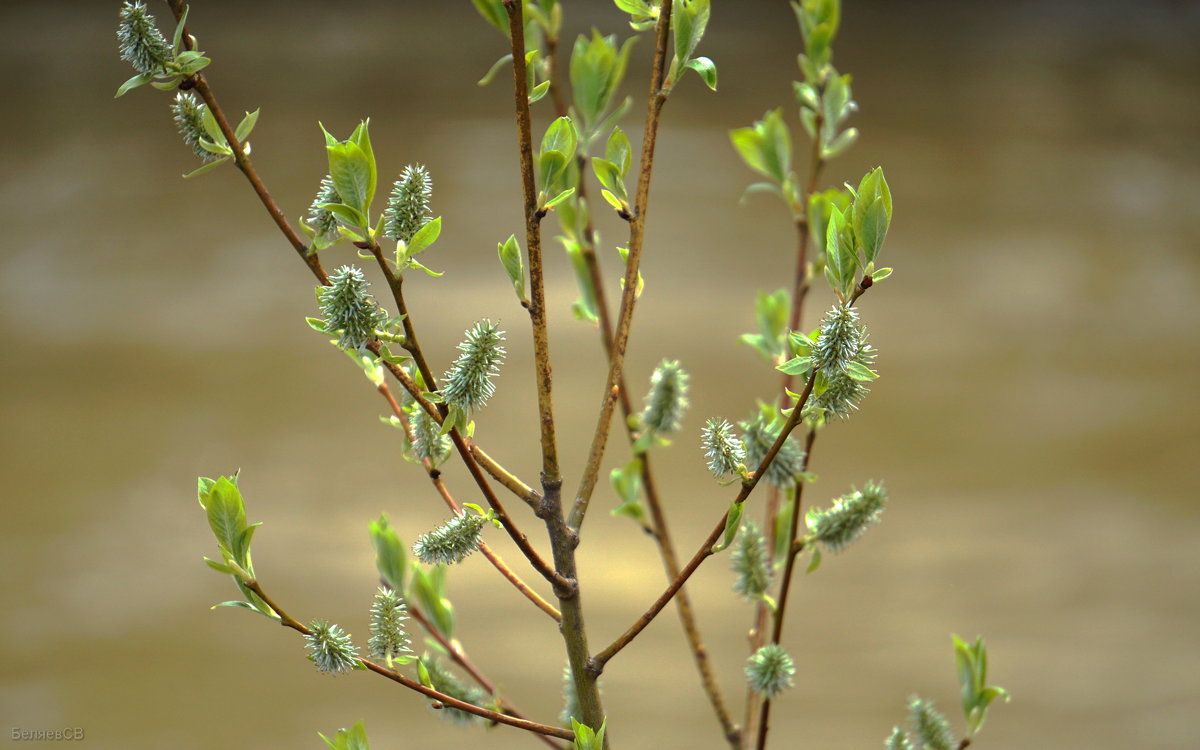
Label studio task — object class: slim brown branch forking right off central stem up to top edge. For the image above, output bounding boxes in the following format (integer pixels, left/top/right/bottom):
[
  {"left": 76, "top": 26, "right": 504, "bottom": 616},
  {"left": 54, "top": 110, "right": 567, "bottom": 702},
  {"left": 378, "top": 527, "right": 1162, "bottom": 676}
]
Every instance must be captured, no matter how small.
[{"left": 568, "top": 0, "right": 671, "bottom": 530}]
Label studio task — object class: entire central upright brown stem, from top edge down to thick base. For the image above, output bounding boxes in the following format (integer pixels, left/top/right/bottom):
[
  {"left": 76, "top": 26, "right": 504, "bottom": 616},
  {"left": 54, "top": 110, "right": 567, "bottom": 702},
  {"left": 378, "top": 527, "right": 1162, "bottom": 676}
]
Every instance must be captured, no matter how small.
[{"left": 504, "top": 0, "right": 605, "bottom": 730}]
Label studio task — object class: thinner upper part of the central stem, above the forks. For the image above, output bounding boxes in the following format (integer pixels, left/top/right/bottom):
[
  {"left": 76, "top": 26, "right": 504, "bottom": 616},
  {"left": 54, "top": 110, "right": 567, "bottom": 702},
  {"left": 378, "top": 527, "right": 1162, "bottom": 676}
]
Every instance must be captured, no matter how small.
[{"left": 504, "top": 0, "right": 559, "bottom": 482}]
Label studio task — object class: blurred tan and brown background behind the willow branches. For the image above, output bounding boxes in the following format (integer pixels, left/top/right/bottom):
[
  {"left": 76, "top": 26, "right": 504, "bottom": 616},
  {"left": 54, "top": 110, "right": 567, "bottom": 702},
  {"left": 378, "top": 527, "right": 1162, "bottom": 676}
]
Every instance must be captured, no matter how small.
[{"left": 0, "top": 0, "right": 1200, "bottom": 750}]
